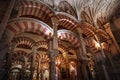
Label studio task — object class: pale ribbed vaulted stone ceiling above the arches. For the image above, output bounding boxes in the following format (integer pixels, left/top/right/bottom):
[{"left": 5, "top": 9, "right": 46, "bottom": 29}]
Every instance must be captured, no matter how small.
[{"left": 41, "top": 0, "right": 120, "bottom": 25}]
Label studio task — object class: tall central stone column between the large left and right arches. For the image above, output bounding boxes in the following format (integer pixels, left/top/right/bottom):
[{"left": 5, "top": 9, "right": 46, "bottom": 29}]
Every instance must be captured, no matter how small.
[{"left": 50, "top": 18, "right": 58, "bottom": 80}]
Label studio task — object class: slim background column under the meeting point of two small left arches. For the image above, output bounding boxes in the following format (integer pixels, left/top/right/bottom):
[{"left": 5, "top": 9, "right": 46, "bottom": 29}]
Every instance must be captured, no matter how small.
[{"left": 30, "top": 46, "right": 37, "bottom": 80}]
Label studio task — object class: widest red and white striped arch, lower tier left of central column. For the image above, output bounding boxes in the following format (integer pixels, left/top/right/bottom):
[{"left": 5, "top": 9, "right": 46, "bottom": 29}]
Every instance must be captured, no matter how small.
[{"left": 7, "top": 18, "right": 53, "bottom": 37}]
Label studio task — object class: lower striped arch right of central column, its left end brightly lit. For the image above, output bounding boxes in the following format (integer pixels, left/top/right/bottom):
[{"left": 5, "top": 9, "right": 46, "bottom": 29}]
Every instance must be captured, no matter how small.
[{"left": 58, "top": 30, "right": 80, "bottom": 47}]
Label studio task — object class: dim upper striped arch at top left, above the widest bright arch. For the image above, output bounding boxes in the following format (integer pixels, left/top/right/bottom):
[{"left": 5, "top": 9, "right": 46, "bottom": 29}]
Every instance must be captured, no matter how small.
[{"left": 19, "top": 0, "right": 55, "bottom": 19}]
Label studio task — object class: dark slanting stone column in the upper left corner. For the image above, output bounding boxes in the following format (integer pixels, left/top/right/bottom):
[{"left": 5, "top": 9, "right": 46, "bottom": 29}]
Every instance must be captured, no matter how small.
[{"left": 0, "top": 0, "right": 16, "bottom": 39}]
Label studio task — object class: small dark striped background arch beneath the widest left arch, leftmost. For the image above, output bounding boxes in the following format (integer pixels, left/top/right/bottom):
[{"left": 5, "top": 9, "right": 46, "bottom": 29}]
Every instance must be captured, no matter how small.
[{"left": 12, "top": 37, "right": 35, "bottom": 49}]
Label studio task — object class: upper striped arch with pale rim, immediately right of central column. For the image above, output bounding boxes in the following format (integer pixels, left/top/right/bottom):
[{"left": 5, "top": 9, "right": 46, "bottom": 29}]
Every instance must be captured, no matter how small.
[{"left": 57, "top": 12, "right": 78, "bottom": 31}]
